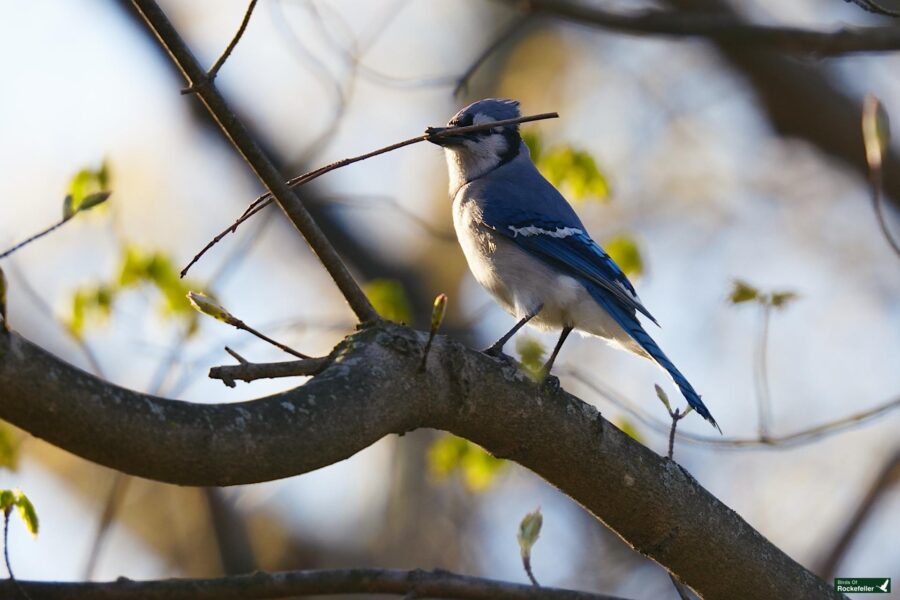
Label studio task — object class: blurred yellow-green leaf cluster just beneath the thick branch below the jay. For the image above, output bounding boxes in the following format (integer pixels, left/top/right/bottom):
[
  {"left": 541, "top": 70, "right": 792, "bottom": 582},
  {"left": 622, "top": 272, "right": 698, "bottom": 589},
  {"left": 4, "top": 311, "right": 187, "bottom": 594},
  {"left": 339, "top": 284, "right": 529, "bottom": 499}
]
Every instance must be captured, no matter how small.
[{"left": 428, "top": 433, "right": 506, "bottom": 492}]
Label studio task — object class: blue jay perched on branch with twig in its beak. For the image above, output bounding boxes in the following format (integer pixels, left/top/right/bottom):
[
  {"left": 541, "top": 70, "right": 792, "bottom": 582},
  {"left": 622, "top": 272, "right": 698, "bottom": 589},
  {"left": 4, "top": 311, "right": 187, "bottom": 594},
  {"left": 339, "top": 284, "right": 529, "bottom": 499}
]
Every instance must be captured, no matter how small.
[{"left": 428, "top": 99, "right": 721, "bottom": 431}]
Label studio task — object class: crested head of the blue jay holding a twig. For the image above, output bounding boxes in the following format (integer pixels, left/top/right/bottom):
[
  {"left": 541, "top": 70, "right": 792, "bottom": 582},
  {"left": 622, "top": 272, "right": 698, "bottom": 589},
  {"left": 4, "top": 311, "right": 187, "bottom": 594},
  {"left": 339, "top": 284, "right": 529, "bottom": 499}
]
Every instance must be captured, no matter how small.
[{"left": 428, "top": 98, "right": 522, "bottom": 190}]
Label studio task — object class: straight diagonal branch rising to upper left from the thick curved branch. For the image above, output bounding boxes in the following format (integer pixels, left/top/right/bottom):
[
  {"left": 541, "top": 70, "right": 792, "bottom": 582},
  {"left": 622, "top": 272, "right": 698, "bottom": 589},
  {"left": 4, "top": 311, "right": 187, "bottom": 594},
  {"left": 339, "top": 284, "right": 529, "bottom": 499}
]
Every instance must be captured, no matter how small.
[{"left": 133, "top": 0, "right": 379, "bottom": 322}]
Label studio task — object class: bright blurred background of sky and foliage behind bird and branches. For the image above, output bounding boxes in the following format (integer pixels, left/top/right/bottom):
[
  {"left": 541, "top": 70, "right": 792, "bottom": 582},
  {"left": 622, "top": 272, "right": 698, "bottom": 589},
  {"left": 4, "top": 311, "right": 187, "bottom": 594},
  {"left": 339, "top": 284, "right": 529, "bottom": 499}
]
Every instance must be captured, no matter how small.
[{"left": 0, "top": 0, "right": 900, "bottom": 599}]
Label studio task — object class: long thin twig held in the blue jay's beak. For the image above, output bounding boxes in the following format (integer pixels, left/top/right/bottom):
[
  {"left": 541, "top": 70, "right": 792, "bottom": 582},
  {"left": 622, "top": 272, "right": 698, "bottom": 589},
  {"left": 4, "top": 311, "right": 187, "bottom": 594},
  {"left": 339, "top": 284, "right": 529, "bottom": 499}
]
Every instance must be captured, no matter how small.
[{"left": 181, "top": 112, "right": 559, "bottom": 277}]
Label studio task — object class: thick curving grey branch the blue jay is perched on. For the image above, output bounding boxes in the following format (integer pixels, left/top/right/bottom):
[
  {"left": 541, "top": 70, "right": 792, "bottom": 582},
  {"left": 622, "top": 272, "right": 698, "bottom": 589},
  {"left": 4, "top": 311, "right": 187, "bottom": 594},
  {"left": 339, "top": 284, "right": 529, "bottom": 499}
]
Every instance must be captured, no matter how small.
[{"left": 0, "top": 323, "right": 841, "bottom": 600}]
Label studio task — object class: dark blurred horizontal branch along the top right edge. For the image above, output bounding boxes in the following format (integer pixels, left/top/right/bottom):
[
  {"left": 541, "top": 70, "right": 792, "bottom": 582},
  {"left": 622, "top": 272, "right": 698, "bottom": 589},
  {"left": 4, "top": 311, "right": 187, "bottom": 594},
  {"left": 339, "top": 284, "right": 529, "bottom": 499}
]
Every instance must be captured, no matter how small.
[{"left": 507, "top": 0, "right": 900, "bottom": 56}]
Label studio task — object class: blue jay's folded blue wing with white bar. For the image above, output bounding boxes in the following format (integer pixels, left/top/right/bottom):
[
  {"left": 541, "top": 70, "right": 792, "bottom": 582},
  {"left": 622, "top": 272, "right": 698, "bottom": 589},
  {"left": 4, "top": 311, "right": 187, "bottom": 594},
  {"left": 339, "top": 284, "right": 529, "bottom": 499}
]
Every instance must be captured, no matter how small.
[{"left": 485, "top": 211, "right": 659, "bottom": 325}]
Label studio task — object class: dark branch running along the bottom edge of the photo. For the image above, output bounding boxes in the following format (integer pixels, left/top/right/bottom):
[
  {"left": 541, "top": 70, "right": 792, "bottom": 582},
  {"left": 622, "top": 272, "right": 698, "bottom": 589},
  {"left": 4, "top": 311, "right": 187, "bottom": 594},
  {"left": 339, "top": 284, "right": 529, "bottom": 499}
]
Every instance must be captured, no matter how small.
[{"left": 0, "top": 569, "right": 623, "bottom": 600}]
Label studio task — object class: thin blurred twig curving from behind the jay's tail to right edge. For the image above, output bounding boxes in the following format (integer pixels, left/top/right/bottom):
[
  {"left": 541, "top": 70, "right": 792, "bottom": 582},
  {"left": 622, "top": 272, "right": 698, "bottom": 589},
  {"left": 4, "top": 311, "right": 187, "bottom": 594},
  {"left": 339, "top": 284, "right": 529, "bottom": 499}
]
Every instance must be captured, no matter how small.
[{"left": 565, "top": 367, "right": 900, "bottom": 449}]
